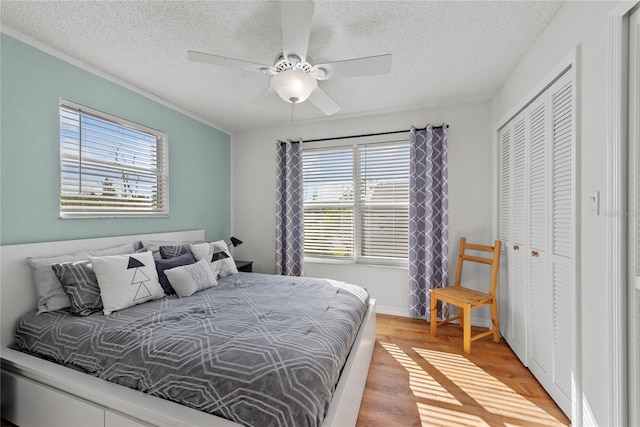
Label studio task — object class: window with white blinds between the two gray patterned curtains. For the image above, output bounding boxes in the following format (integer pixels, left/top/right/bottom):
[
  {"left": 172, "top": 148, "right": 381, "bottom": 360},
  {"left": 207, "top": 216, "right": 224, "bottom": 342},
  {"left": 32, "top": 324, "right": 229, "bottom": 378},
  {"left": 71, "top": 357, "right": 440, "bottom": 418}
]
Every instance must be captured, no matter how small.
[{"left": 302, "top": 141, "right": 409, "bottom": 264}]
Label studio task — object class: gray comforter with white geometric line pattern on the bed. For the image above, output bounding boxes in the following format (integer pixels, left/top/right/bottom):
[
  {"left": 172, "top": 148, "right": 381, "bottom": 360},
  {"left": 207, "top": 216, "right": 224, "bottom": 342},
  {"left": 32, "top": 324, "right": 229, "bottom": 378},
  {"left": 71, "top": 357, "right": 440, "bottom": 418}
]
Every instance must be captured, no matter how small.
[{"left": 15, "top": 273, "right": 369, "bottom": 427}]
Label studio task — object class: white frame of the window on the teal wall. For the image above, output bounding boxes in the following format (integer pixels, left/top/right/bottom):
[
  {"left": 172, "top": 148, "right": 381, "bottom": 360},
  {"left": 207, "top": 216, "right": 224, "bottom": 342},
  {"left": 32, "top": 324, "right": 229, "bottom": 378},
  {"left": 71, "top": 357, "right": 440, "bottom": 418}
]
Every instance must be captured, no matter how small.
[{"left": 58, "top": 98, "right": 169, "bottom": 219}]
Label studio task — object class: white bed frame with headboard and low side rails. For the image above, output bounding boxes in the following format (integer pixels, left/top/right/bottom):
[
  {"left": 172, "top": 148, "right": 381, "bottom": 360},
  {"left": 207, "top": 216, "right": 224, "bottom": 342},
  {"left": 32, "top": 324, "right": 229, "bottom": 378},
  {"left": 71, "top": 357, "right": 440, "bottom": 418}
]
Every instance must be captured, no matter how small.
[{"left": 0, "top": 230, "right": 376, "bottom": 427}]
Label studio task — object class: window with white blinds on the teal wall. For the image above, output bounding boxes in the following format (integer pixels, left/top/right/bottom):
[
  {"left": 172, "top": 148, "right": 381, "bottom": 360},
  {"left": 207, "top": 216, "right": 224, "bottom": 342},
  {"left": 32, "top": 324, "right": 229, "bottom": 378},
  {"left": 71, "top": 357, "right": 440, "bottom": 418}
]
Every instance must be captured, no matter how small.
[{"left": 60, "top": 100, "right": 169, "bottom": 218}]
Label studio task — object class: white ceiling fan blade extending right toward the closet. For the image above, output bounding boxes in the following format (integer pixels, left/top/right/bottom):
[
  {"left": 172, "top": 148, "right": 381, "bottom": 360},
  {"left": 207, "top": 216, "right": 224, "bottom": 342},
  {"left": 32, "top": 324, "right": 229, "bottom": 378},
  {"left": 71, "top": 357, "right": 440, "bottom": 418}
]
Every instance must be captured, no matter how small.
[{"left": 312, "top": 54, "right": 391, "bottom": 80}]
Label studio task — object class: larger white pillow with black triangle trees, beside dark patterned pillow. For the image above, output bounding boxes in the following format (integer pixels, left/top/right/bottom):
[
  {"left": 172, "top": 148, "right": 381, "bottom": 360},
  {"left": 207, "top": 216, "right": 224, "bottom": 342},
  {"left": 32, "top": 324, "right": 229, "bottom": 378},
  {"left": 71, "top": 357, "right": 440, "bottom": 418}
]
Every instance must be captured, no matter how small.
[{"left": 89, "top": 252, "right": 164, "bottom": 314}]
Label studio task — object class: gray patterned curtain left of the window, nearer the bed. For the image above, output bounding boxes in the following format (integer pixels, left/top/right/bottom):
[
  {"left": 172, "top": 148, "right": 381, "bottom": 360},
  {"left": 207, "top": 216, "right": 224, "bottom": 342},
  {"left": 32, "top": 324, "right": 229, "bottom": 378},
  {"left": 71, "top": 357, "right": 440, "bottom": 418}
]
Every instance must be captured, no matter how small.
[{"left": 276, "top": 141, "right": 304, "bottom": 276}]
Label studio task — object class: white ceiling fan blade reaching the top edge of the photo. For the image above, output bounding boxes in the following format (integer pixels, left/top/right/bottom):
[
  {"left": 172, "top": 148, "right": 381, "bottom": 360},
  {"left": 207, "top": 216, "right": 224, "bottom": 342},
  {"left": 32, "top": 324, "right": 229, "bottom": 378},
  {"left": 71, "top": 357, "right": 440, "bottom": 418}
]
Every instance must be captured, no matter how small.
[{"left": 280, "top": 0, "right": 313, "bottom": 61}]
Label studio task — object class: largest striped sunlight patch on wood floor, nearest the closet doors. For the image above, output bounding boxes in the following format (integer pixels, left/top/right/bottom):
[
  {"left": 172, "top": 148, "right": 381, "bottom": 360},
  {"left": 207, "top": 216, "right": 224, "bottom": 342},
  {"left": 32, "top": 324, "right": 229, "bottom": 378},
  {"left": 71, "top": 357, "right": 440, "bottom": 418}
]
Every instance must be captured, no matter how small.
[{"left": 413, "top": 348, "right": 562, "bottom": 426}]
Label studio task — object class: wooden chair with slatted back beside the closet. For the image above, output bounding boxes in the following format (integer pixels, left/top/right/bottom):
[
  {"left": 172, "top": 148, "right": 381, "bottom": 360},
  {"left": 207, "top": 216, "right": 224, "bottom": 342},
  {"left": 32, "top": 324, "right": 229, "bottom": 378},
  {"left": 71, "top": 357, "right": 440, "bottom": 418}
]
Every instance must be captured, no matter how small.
[{"left": 431, "top": 237, "right": 502, "bottom": 354}]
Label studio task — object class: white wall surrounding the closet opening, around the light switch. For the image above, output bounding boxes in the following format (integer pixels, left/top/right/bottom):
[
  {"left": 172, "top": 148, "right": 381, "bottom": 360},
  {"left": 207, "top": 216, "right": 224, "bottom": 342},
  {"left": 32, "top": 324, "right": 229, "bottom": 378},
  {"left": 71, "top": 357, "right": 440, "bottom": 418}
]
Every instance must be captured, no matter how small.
[{"left": 492, "top": 1, "right": 617, "bottom": 426}]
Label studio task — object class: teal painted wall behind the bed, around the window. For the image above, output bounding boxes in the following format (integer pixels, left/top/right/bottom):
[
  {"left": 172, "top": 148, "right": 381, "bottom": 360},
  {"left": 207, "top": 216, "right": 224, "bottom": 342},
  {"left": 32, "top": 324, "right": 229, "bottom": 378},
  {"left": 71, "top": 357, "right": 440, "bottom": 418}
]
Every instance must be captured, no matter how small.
[{"left": 0, "top": 34, "right": 231, "bottom": 245}]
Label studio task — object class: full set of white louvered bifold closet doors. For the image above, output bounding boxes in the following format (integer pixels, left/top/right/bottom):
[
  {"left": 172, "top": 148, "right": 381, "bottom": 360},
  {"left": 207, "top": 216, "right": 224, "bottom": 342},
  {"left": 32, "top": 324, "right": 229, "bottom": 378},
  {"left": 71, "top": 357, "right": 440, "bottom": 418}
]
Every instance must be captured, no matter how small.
[{"left": 498, "top": 71, "right": 576, "bottom": 416}]
